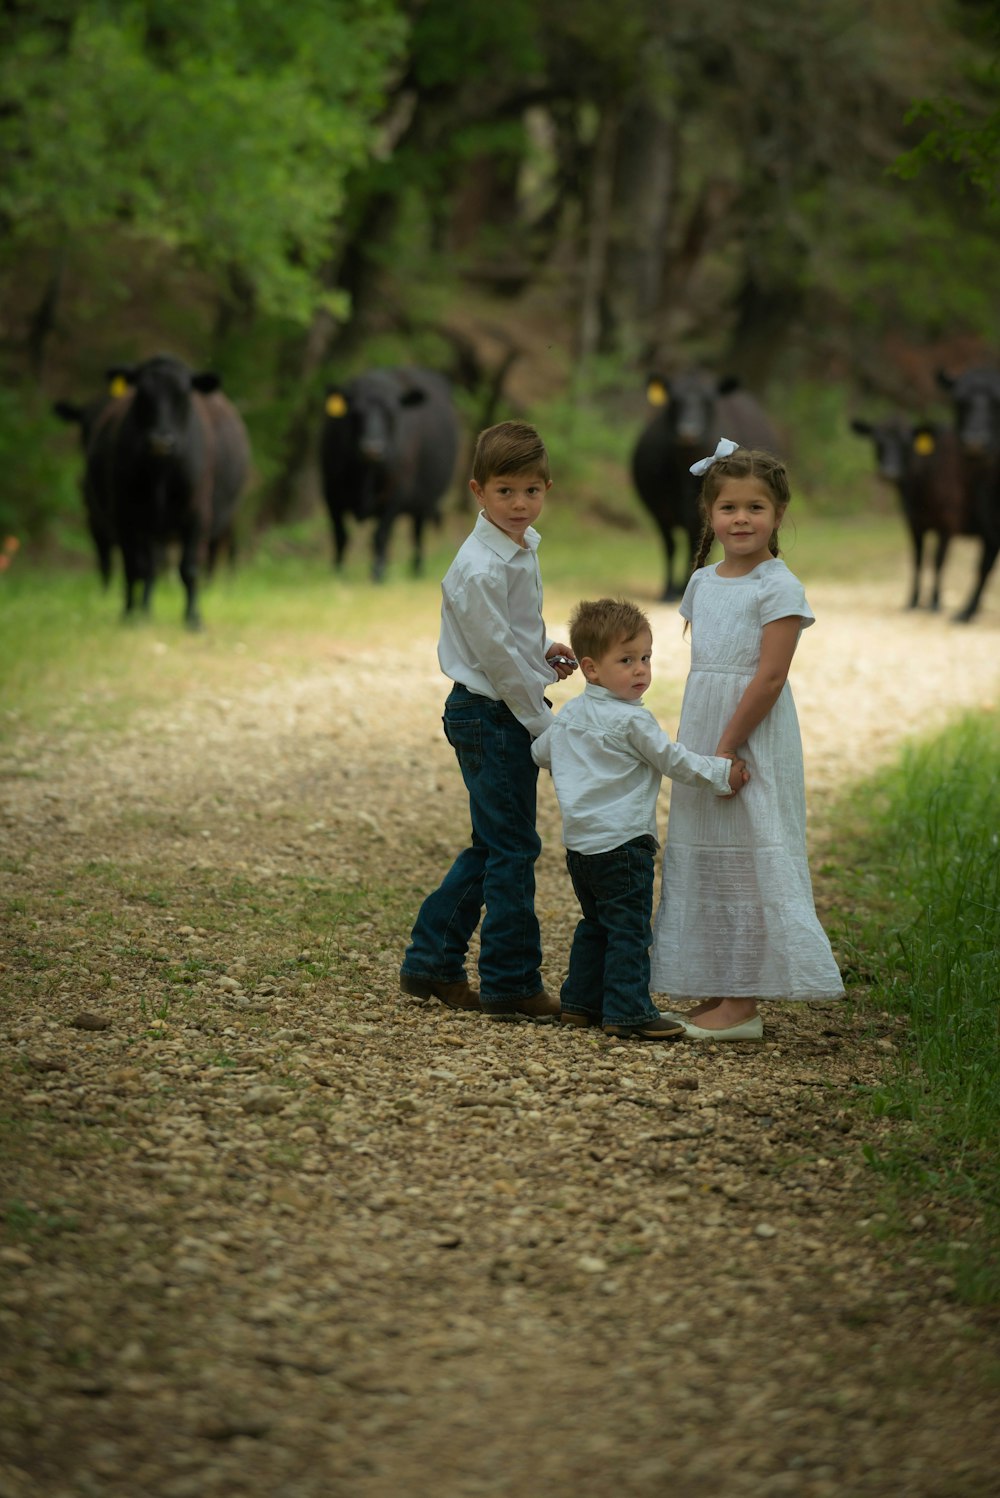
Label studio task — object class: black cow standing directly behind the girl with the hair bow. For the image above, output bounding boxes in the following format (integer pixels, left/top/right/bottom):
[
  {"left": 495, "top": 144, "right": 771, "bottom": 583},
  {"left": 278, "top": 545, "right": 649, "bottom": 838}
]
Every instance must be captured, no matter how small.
[{"left": 632, "top": 370, "right": 780, "bottom": 598}]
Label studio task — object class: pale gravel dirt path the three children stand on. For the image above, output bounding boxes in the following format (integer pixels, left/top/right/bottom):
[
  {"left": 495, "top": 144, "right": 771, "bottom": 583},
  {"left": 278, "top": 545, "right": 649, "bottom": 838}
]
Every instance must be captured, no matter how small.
[{"left": 0, "top": 560, "right": 1000, "bottom": 1498}]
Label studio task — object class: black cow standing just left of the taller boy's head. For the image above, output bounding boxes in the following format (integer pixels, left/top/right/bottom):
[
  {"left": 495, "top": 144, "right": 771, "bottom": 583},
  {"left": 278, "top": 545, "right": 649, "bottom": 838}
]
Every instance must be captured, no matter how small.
[{"left": 320, "top": 369, "right": 460, "bottom": 581}]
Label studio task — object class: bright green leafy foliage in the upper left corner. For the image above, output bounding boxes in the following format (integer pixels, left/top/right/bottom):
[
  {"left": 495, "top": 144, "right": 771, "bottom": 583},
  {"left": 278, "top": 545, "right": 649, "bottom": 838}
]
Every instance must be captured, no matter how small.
[{"left": 0, "top": 0, "right": 404, "bottom": 322}]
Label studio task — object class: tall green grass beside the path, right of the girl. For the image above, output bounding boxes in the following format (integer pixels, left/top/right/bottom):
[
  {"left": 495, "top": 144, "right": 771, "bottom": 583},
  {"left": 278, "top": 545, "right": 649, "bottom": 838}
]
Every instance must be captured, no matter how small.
[{"left": 834, "top": 715, "right": 1000, "bottom": 1305}]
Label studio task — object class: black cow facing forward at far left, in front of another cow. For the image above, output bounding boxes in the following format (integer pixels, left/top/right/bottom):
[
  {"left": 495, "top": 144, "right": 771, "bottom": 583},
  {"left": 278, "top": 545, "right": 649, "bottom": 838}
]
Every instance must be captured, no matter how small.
[{"left": 87, "top": 355, "right": 250, "bottom": 629}]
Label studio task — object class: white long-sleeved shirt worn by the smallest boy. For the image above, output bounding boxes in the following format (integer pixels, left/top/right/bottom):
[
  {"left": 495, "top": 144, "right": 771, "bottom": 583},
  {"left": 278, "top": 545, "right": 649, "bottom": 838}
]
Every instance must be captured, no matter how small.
[{"left": 531, "top": 682, "right": 732, "bottom": 854}]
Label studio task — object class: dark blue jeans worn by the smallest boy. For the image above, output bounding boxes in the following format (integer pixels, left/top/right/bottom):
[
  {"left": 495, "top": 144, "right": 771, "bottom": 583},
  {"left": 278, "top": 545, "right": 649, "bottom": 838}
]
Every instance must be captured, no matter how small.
[{"left": 560, "top": 837, "right": 660, "bottom": 1025}]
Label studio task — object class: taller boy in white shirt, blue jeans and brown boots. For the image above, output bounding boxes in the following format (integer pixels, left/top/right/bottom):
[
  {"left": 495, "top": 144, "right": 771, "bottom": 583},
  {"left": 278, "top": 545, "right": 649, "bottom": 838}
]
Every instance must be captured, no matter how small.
[{"left": 400, "top": 421, "right": 576, "bottom": 1019}]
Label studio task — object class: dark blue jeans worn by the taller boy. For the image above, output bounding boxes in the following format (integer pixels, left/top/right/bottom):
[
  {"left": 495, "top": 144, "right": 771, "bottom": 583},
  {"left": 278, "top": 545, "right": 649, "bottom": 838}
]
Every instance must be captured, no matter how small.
[{"left": 401, "top": 685, "right": 542, "bottom": 1010}]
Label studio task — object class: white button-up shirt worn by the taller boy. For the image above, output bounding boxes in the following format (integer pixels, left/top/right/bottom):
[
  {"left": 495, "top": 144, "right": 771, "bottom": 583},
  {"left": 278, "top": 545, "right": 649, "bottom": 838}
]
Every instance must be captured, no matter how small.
[{"left": 437, "top": 511, "right": 558, "bottom": 736}]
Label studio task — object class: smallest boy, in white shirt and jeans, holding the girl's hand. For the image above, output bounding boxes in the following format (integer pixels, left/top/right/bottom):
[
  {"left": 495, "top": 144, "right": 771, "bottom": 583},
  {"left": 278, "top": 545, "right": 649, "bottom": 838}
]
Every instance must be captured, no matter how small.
[{"left": 531, "top": 598, "right": 747, "bottom": 1040}]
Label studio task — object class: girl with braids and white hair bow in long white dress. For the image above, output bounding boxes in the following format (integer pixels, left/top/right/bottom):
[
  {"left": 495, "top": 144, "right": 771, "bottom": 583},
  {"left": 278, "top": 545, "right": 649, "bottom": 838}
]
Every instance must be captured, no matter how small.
[{"left": 650, "top": 437, "right": 844, "bottom": 1040}]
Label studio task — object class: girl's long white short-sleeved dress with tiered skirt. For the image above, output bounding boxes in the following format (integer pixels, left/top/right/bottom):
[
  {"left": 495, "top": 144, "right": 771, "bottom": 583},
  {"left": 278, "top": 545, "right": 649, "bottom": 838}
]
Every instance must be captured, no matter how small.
[{"left": 650, "top": 557, "right": 844, "bottom": 999}]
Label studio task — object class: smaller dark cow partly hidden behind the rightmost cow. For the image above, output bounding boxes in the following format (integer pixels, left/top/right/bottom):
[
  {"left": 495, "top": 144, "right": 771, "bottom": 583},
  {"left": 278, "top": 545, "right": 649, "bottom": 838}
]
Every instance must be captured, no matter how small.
[{"left": 850, "top": 416, "right": 975, "bottom": 608}]
